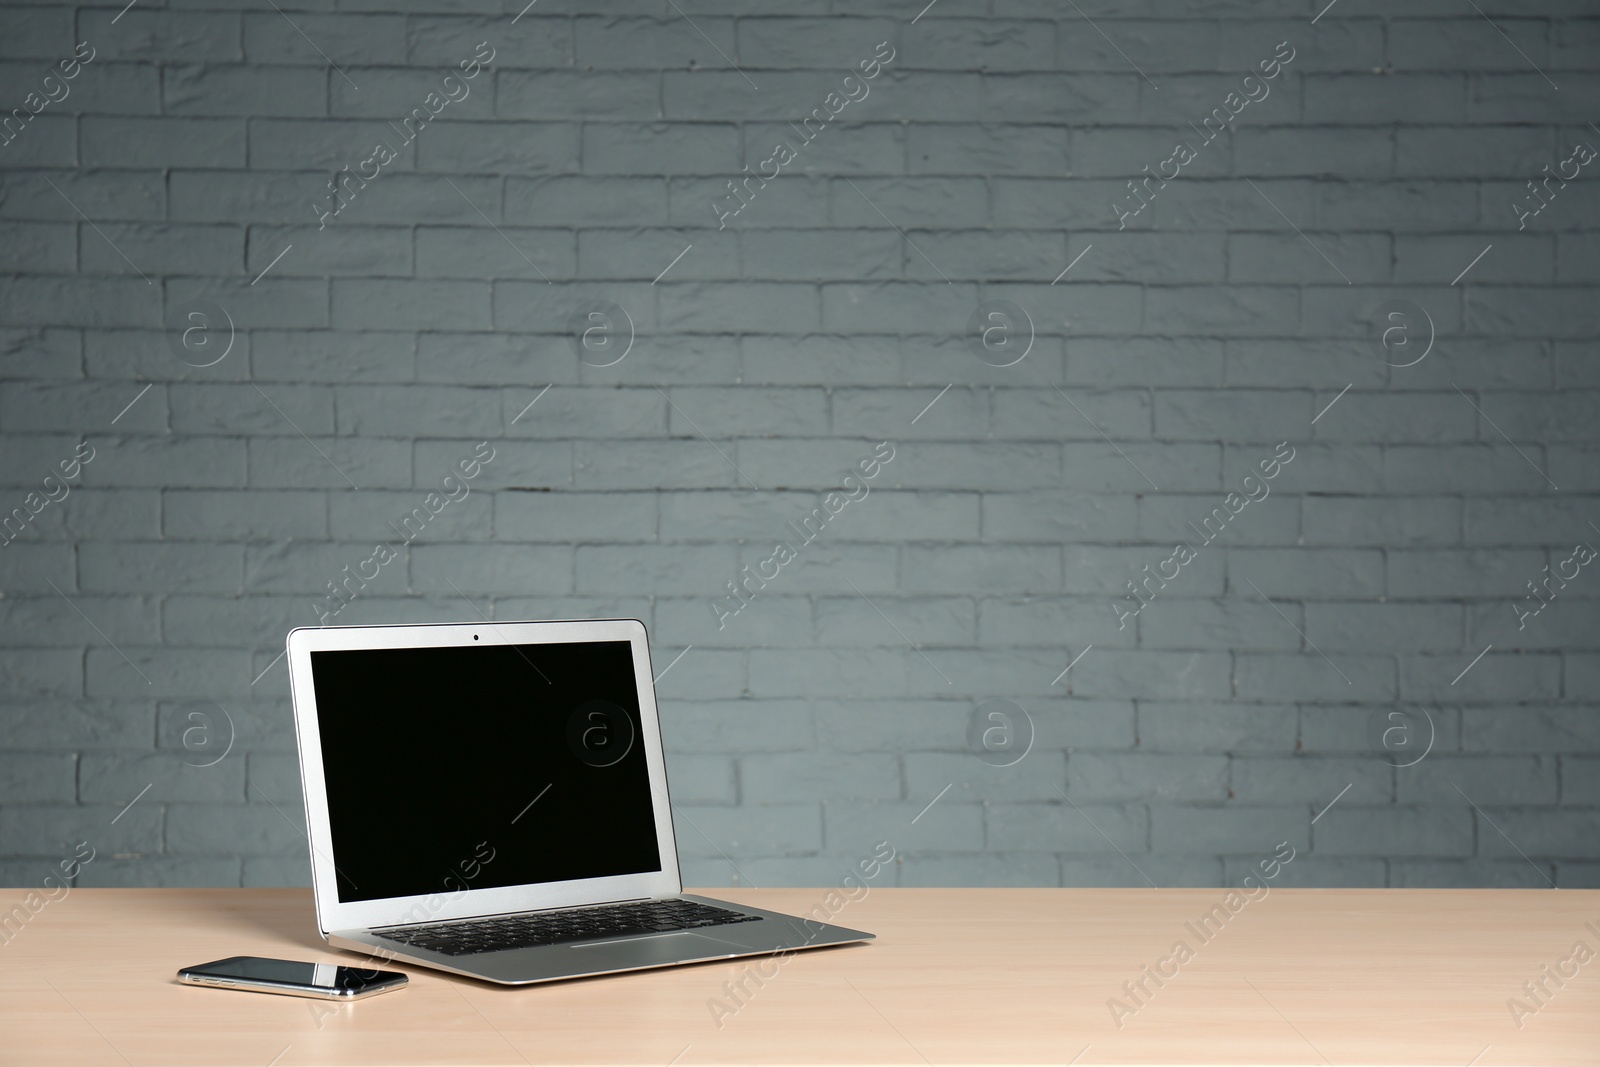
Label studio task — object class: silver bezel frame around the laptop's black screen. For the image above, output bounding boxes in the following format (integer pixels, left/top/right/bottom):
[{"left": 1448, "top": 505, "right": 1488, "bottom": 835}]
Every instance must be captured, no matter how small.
[{"left": 286, "top": 619, "right": 683, "bottom": 937}]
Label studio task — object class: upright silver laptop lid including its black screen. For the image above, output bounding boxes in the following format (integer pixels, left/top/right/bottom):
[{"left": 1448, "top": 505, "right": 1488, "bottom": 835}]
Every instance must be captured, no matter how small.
[{"left": 288, "top": 619, "right": 683, "bottom": 933}]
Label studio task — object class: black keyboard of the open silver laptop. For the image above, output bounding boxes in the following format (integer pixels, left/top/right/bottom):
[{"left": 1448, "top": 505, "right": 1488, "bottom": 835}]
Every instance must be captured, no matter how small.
[{"left": 373, "top": 899, "right": 762, "bottom": 957}]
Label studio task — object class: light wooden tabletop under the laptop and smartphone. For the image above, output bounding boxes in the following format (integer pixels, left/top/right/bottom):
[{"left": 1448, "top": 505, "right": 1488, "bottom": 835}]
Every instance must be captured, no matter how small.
[{"left": 0, "top": 888, "right": 1600, "bottom": 1067}]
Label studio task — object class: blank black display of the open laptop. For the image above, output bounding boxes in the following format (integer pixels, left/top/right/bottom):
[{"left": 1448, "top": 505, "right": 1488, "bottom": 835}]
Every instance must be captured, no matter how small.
[{"left": 310, "top": 641, "right": 661, "bottom": 902}]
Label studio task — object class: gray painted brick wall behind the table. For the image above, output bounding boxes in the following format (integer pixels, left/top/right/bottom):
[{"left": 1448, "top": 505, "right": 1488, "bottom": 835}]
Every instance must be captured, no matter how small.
[{"left": 0, "top": 0, "right": 1600, "bottom": 886}]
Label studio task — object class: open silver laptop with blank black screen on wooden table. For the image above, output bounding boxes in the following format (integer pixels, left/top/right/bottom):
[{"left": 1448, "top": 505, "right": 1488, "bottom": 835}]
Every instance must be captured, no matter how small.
[{"left": 288, "top": 619, "right": 872, "bottom": 985}]
